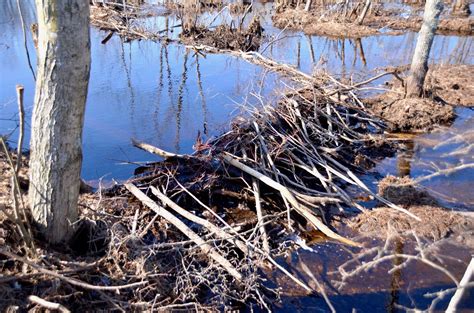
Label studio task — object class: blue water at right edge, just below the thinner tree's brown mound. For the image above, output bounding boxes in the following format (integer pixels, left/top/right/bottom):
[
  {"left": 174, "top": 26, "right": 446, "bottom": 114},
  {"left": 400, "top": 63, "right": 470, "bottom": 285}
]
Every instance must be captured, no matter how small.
[{"left": 375, "top": 108, "right": 474, "bottom": 211}]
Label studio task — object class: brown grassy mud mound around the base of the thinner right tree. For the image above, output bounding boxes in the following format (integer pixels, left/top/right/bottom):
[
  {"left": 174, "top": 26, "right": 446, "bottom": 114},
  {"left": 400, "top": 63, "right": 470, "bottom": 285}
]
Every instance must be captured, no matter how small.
[{"left": 365, "top": 65, "right": 474, "bottom": 132}]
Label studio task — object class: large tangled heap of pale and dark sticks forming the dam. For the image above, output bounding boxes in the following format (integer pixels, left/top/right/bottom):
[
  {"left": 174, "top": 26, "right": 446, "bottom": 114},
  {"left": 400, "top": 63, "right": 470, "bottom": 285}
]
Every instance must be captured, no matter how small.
[{"left": 124, "top": 77, "right": 416, "bottom": 304}]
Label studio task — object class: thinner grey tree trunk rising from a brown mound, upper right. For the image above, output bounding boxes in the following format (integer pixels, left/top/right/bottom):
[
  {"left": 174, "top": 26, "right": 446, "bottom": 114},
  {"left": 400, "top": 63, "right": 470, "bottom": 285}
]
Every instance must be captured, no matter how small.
[{"left": 407, "top": 0, "right": 443, "bottom": 98}]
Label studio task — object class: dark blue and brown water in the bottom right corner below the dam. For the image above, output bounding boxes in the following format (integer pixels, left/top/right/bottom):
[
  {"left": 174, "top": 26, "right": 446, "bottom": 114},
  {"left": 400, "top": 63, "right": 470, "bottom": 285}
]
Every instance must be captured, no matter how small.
[{"left": 268, "top": 238, "right": 474, "bottom": 312}]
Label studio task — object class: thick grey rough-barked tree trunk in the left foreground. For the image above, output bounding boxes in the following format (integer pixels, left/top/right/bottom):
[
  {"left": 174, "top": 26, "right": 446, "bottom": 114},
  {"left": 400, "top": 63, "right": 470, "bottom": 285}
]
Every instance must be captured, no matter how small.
[{"left": 29, "top": 0, "right": 90, "bottom": 243}]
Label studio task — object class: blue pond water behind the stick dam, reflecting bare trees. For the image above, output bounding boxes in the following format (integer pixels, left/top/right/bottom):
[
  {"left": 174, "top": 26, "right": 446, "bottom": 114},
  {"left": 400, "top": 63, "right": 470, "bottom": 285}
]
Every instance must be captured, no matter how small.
[{"left": 0, "top": 0, "right": 474, "bottom": 185}]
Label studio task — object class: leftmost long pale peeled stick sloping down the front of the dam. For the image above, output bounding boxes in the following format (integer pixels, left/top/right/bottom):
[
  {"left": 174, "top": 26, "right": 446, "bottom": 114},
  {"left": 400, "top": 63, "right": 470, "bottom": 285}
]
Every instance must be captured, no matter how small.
[{"left": 125, "top": 184, "right": 242, "bottom": 281}]
